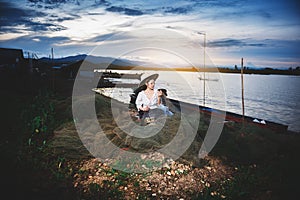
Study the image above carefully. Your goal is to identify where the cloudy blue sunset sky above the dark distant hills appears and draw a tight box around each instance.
[0,0,300,68]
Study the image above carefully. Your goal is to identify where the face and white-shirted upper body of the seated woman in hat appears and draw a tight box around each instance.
[135,79,162,119]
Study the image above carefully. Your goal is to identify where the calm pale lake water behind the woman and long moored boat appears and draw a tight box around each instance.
[96,70,300,132]
